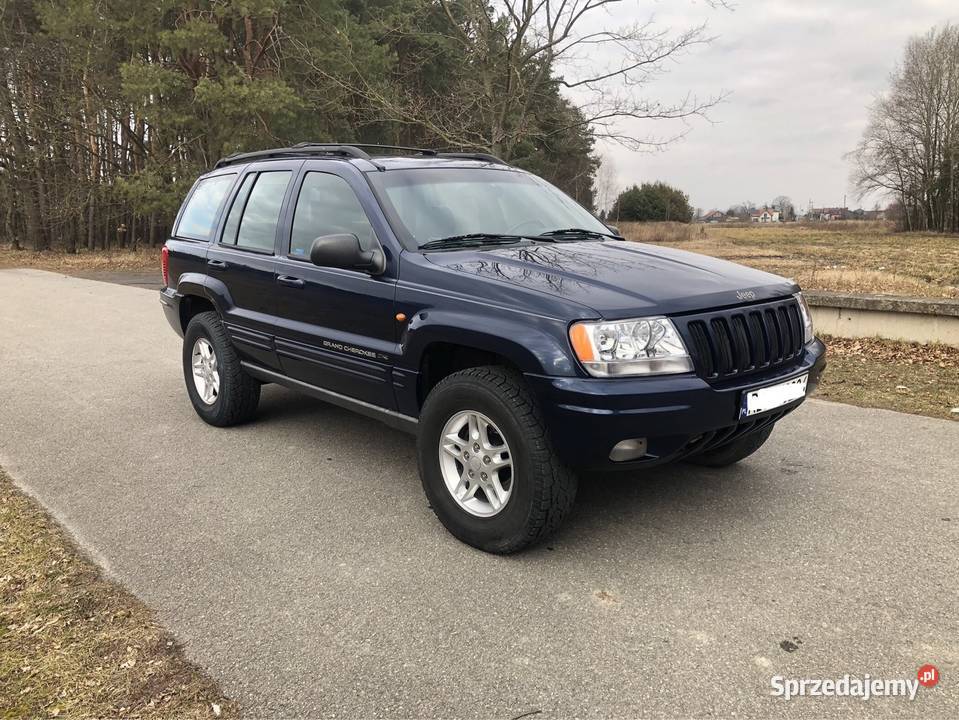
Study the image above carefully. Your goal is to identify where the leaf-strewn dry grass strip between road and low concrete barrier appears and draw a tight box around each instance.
[816,337,959,420]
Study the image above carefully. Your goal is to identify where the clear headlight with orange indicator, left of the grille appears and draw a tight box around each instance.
[569,317,693,377]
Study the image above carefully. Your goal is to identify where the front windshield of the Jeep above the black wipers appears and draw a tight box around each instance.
[367,168,610,247]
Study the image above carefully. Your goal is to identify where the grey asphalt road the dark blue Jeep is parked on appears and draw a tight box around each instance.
[0,270,959,719]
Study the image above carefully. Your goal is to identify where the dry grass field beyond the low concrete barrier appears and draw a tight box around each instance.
[619,221,959,298]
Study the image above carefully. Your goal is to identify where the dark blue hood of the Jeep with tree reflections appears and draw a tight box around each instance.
[425,240,798,319]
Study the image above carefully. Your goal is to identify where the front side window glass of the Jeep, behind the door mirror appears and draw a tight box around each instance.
[290,172,377,260]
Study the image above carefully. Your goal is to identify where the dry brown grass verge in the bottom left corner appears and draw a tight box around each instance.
[0,471,238,718]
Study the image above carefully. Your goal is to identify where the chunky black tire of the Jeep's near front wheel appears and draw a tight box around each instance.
[417,366,577,554]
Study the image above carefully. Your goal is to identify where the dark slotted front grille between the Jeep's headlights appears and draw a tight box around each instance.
[679,298,803,381]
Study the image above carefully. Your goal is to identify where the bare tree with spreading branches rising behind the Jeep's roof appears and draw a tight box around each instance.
[294,0,725,159]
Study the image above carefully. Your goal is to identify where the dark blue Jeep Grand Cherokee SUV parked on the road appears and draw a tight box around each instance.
[161,143,825,553]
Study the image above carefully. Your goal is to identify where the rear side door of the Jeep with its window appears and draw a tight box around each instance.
[207,161,302,369]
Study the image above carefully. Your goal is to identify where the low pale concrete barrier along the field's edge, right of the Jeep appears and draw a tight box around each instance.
[803,290,959,347]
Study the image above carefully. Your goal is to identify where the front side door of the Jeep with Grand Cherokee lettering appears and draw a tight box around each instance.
[275,161,397,409]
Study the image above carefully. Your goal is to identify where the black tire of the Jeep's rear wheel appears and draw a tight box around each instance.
[183,311,260,427]
